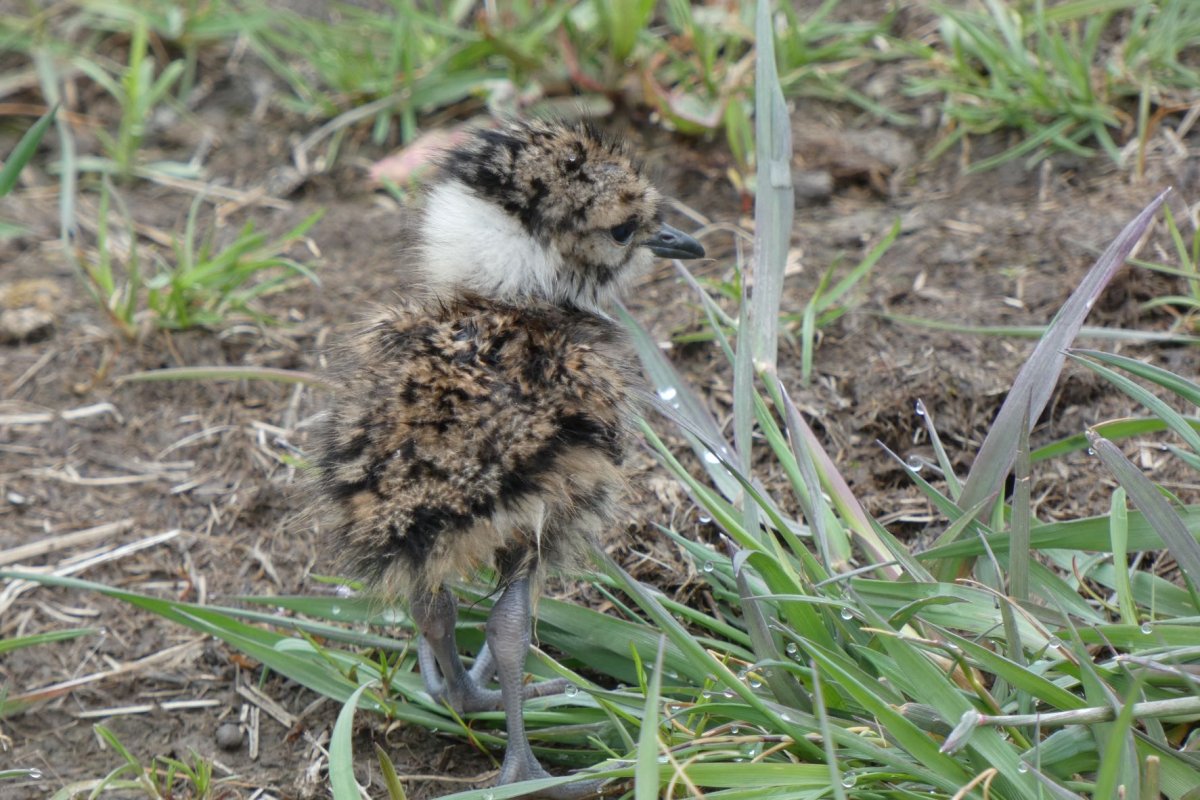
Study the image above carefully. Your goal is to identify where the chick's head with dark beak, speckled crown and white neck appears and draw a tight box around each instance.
[416,121,704,311]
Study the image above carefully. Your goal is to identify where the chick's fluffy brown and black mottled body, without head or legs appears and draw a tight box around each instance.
[319,296,635,597]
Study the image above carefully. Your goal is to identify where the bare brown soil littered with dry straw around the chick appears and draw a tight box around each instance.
[0,6,1200,799]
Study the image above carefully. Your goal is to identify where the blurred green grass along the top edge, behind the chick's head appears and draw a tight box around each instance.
[241,0,902,170]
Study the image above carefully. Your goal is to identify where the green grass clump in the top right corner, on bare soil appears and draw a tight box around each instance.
[910,0,1200,170]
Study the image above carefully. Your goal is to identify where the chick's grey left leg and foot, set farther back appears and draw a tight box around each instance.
[412,589,569,714]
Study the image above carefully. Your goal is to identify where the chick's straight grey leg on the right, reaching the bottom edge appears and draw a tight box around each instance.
[487,576,602,800]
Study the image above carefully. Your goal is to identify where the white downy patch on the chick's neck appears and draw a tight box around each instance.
[418,180,563,301]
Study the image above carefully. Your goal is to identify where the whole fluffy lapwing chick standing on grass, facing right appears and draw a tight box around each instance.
[318,122,704,800]
